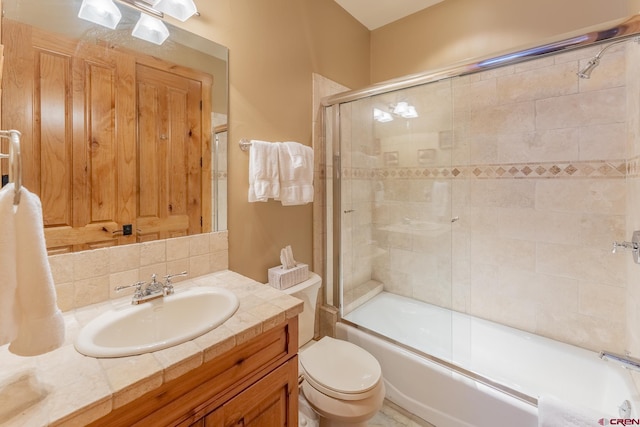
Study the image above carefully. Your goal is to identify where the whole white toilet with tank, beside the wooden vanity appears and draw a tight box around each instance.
[284,273,384,427]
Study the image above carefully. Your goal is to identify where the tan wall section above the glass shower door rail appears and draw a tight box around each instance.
[371,0,640,82]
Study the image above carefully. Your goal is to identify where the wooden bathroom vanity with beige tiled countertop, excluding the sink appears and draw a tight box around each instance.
[0,271,302,427]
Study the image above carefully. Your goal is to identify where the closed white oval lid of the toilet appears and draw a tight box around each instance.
[300,337,381,399]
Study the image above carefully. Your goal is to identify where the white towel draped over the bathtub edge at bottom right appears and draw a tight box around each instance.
[538,396,611,427]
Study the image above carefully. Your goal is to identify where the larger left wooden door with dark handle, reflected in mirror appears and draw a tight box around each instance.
[2,20,136,253]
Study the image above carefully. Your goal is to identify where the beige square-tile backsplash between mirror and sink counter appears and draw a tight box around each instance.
[49,231,229,311]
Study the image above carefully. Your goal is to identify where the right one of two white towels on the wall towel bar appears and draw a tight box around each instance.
[278,142,313,206]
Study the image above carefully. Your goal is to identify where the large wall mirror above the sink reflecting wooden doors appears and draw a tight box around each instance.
[2,0,228,254]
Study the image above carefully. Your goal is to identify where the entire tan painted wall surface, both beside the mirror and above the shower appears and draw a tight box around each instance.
[170,0,640,288]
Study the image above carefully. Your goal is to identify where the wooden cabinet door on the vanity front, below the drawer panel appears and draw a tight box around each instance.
[201,357,298,427]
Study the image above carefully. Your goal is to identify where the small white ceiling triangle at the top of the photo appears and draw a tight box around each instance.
[335,0,444,30]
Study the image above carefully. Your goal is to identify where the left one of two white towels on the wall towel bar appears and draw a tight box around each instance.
[249,140,281,202]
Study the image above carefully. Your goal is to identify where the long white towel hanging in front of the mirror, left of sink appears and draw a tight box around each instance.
[9,187,65,356]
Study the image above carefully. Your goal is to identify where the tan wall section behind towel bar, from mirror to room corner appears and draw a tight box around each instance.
[172,0,369,282]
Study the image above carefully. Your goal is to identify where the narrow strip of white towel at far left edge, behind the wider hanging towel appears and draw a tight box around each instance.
[0,184,18,345]
